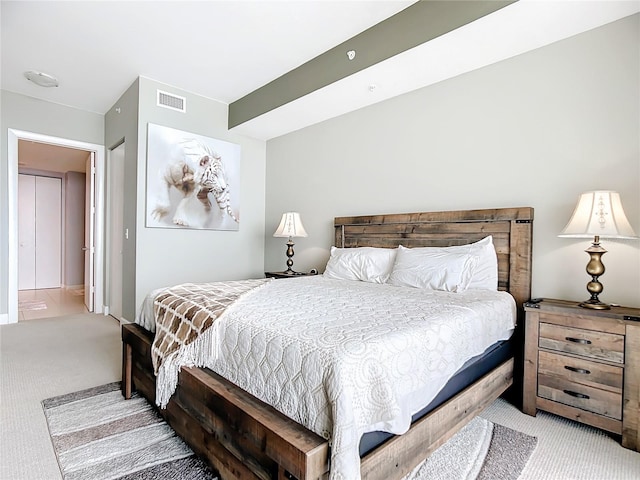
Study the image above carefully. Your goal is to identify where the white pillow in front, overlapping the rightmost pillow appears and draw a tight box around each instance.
[388,245,478,292]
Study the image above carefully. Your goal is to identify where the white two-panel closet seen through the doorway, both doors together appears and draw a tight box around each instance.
[18,174,62,290]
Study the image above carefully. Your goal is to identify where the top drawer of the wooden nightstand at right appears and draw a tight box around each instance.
[539,322,624,364]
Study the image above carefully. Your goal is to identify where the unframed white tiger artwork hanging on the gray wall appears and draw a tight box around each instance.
[146,123,240,230]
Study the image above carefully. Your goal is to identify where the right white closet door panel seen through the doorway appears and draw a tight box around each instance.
[35,177,62,288]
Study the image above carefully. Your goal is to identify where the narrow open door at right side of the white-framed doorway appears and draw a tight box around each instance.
[82,152,96,312]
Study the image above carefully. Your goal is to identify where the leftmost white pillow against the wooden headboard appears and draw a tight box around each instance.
[324,247,396,283]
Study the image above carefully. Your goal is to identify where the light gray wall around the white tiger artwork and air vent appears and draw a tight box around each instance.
[106,78,266,320]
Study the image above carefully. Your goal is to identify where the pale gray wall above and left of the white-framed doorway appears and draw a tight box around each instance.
[0,90,104,315]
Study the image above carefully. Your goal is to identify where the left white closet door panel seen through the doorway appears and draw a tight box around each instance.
[18,175,36,290]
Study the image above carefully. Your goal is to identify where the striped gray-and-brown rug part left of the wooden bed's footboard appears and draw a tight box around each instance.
[42,382,217,480]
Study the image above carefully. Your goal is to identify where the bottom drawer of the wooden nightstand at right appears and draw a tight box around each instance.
[538,374,622,420]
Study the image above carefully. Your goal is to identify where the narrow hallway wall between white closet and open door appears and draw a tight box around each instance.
[62,172,86,287]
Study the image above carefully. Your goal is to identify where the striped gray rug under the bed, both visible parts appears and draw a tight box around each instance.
[42,382,537,480]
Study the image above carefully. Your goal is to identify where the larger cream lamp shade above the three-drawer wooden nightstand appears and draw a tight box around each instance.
[558,191,638,239]
